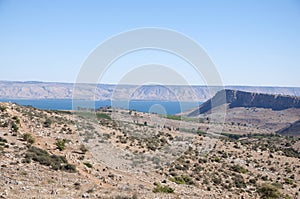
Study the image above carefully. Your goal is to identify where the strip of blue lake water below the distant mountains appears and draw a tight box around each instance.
[0,99,201,115]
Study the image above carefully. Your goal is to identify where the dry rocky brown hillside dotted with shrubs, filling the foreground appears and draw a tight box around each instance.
[0,90,300,199]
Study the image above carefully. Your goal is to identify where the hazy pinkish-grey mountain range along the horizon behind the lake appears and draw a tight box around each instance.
[0,81,300,102]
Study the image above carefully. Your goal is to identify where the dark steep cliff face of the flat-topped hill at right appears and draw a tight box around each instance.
[188,90,300,117]
